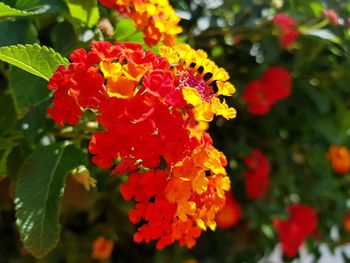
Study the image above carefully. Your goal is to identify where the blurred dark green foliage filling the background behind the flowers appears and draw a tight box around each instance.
[0,0,350,263]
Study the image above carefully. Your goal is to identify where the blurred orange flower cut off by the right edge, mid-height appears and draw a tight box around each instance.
[327,145,350,174]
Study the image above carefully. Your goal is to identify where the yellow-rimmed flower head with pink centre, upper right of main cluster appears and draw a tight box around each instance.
[160,44,236,122]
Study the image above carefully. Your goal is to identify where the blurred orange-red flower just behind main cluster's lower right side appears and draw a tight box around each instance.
[215,192,241,229]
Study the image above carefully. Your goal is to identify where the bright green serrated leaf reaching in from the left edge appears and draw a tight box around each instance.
[0,44,68,81]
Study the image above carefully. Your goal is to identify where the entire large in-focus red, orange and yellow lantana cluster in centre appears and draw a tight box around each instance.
[48,41,235,249]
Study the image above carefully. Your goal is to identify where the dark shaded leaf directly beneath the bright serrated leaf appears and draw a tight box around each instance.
[9,67,50,118]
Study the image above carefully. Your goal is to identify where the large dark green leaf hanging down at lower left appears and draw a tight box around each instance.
[15,143,86,257]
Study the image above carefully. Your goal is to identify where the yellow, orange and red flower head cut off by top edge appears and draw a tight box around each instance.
[100,0,182,46]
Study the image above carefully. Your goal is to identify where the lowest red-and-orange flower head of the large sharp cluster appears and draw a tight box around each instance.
[120,146,230,249]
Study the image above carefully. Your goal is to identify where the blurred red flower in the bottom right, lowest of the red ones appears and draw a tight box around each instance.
[273,204,318,257]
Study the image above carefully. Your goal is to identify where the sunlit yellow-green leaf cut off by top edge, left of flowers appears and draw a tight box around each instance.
[66,0,100,27]
